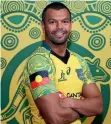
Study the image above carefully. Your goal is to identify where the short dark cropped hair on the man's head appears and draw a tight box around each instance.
[42,2,71,22]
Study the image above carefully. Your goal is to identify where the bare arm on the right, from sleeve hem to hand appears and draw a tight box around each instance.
[61,83,103,117]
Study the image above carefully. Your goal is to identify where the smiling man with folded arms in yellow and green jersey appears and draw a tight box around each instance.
[24,2,103,124]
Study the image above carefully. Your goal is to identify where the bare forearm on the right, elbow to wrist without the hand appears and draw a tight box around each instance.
[72,97,103,116]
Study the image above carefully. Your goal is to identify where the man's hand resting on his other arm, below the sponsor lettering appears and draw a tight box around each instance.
[60,98,73,108]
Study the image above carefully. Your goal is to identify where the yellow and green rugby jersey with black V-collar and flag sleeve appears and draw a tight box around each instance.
[24,43,94,124]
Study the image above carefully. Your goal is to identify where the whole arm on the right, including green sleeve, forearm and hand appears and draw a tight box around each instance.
[61,59,103,116]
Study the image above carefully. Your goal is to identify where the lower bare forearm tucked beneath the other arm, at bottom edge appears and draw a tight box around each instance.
[42,104,80,124]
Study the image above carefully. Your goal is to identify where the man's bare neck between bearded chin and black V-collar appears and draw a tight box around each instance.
[45,40,67,56]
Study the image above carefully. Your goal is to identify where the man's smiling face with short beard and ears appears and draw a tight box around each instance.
[42,9,71,45]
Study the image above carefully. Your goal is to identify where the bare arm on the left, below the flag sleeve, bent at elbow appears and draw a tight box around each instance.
[35,93,80,124]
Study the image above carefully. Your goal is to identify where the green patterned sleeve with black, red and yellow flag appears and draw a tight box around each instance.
[27,55,58,100]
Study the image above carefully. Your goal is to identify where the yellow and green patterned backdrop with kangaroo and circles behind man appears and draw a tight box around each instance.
[0,0,111,124]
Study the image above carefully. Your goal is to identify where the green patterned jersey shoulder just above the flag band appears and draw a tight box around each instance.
[26,46,55,75]
